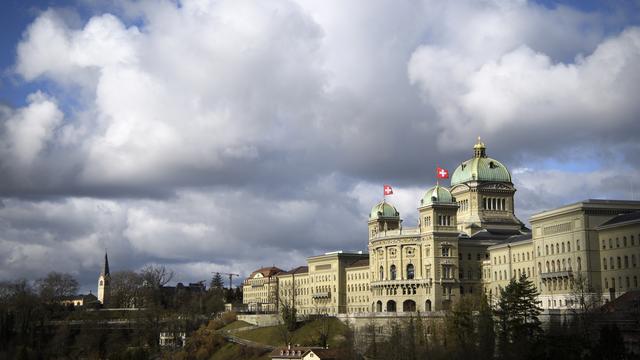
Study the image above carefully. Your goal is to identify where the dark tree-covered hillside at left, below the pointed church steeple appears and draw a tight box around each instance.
[0,266,241,359]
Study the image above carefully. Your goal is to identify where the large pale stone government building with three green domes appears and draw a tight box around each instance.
[243,140,640,314]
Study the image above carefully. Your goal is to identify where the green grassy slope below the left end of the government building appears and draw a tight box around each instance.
[236,318,347,348]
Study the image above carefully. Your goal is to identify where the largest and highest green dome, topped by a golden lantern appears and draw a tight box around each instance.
[451,139,511,186]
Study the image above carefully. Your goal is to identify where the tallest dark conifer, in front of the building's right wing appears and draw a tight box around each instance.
[495,275,542,359]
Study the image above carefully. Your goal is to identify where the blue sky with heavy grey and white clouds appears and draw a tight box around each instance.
[0,0,640,292]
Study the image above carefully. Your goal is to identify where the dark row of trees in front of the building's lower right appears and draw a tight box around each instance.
[360,276,634,360]
